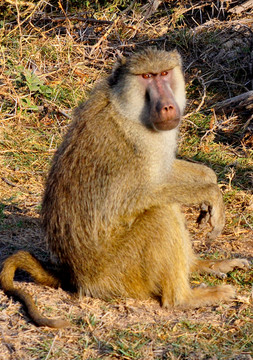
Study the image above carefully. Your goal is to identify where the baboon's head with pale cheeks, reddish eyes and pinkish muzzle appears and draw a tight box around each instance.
[111,51,186,131]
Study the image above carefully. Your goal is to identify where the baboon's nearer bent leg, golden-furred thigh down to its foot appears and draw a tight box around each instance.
[116,204,234,308]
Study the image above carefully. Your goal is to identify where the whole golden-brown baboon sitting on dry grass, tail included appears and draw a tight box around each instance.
[0,48,249,327]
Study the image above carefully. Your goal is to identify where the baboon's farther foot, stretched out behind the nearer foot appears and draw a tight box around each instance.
[191,259,250,278]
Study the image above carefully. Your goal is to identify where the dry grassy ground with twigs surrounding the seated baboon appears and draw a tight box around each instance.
[0,0,253,360]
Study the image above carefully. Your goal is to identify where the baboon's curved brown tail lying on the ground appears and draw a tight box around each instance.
[0,251,70,328]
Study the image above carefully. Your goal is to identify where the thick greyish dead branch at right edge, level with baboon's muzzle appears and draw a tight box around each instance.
[214,91,253,113]
